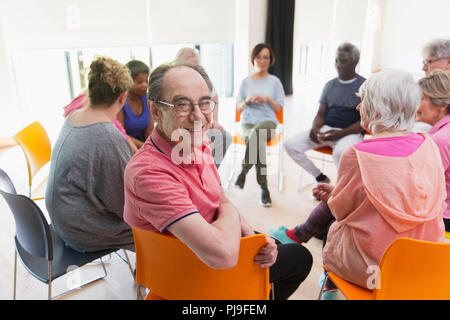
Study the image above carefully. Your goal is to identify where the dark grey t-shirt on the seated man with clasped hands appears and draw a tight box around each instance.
[319,75,366,129]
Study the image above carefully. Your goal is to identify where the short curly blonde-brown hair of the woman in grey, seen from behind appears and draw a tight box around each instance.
[88,56,133,106]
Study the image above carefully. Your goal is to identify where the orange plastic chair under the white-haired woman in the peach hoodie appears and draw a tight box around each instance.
[319,238,450,300]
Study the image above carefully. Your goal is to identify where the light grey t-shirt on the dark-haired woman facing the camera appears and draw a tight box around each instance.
[237,74,285,125]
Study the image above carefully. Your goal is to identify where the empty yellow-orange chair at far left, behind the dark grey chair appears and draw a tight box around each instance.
[13,121,52,200]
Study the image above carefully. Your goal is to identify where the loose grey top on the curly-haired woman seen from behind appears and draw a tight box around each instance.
[45,118,133,251]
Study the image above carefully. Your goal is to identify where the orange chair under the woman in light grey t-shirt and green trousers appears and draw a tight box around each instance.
[227,106,284,192]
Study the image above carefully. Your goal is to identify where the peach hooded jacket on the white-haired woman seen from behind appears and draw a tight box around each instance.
[323,134,446,287]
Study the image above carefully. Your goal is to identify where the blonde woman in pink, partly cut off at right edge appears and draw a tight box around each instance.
[417,70,450,231]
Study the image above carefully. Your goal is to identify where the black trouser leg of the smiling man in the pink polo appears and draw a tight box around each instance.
[269,240,313,300]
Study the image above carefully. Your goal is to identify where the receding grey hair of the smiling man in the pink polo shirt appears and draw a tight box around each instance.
[148,61,213,101]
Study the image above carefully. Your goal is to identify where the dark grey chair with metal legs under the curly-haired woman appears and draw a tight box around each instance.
[0,169,129,300]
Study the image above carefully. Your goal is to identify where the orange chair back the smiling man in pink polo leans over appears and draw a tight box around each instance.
[132,228,270,300]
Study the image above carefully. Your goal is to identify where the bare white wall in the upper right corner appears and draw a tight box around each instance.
[376,0,450,78]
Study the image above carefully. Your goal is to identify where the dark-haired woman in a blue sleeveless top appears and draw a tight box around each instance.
[117,60,153,148]
